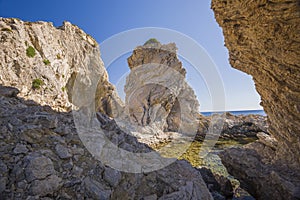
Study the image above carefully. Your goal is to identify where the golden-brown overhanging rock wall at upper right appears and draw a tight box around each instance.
[212,0,300,167]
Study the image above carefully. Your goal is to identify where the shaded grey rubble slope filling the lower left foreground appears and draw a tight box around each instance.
[0,86,212,200]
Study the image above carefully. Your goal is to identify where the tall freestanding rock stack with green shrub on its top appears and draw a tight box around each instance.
[121,42,199,144]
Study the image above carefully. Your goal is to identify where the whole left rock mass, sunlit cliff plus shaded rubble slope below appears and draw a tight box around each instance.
[0,18,212,200]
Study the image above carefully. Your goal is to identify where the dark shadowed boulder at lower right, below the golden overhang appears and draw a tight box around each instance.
[220,143,300,200]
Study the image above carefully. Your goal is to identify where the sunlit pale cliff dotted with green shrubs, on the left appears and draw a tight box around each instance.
[0,18,122,115]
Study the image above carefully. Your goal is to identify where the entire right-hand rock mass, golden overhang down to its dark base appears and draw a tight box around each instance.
[212,0,300,199]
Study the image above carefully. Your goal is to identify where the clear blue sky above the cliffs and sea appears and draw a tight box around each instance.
[0,0,262,111]
